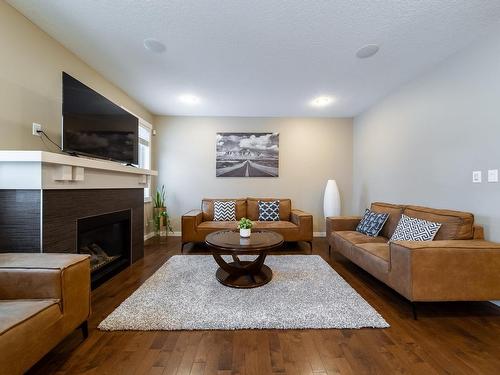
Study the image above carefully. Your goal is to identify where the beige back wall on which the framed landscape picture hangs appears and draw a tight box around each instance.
[153,117,352,232]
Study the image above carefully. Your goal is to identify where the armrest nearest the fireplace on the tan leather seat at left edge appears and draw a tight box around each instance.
[0,253,90,324]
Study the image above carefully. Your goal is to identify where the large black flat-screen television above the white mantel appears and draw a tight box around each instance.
[62,72,139,165]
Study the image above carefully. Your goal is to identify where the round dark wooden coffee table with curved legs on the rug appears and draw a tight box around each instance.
[205,230,283,288]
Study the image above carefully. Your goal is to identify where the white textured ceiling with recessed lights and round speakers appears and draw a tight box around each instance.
[8,0,500,117]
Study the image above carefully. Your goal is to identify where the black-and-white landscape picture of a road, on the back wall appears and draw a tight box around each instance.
[215,133,279,177]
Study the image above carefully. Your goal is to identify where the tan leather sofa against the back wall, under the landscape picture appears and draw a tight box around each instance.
[181,198,313,249]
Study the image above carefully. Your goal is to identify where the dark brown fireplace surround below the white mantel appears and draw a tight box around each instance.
[0,188,144,286]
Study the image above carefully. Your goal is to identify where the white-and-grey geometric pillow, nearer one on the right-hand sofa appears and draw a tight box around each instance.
[389,215,441,242]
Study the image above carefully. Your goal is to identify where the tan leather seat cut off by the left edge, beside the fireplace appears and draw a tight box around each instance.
[0,253,90,374]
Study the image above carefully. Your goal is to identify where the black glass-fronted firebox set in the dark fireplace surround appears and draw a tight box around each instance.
[77,210,132,288]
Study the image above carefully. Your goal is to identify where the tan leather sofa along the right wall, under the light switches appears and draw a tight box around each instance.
[326,202,500,312]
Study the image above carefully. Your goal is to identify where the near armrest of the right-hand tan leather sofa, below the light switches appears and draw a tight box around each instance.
[390,240,500,301]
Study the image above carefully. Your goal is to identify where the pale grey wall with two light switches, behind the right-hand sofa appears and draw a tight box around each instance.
[353,33,500,241]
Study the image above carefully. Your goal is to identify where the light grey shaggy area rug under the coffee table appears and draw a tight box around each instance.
[99,255,389,331]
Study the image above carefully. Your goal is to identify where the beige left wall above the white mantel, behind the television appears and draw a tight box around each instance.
[0,1,153,151]
